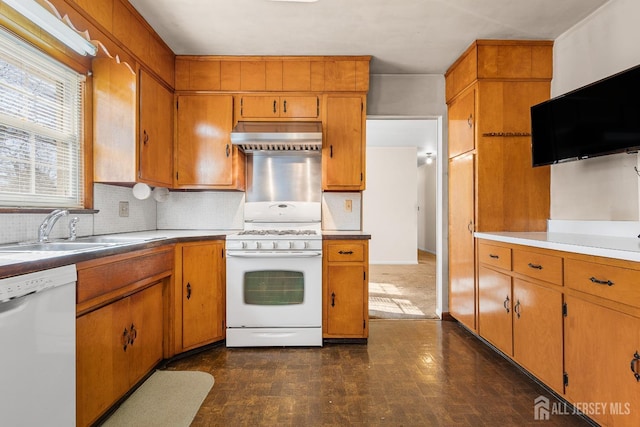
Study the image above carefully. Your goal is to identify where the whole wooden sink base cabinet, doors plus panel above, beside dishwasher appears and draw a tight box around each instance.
[76,247,173,426]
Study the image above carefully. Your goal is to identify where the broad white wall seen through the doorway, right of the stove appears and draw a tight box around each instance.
[362,147,418,264]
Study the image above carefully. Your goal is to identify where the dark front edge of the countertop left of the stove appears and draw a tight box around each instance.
[0,234,227,279]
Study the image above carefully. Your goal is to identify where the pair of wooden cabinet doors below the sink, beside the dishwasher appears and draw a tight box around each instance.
[76,282,163,426]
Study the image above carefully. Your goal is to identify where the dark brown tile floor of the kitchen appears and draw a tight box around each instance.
[167,320,589,427]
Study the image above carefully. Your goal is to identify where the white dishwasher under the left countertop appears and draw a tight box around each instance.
[0,265,77,427]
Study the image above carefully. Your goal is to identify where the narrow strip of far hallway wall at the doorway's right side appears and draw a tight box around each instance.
[418,162,437,254]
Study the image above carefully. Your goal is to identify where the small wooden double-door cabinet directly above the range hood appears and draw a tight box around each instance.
[238,95,320,119]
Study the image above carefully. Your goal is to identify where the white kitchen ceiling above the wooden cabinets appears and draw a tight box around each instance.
[129,0,608,74]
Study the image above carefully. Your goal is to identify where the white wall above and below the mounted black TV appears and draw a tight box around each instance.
[551,0,640,221]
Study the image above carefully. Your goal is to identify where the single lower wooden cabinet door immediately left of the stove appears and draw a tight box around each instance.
[172,242,225,354]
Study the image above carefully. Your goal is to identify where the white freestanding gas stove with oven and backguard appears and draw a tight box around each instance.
[226,202,322,347]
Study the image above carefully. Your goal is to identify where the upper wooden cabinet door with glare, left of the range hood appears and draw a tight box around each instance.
[176,95,233,187]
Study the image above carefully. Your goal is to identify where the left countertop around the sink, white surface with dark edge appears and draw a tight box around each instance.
[0,230,232,279]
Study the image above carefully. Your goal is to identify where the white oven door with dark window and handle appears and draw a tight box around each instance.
[226,251,322,328]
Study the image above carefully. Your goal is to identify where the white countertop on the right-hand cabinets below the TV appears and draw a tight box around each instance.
[474,232,640,262]
